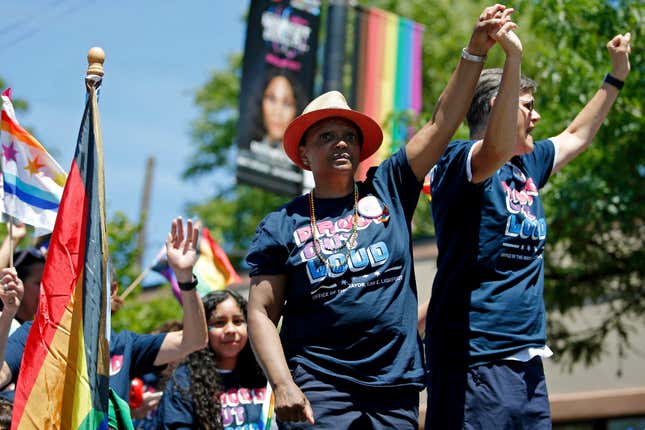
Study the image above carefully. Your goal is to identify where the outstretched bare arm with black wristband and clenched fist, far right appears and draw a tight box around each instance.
[552,33,631,174]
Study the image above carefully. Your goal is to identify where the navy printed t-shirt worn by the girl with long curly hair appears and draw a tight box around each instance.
[157,364,266,430]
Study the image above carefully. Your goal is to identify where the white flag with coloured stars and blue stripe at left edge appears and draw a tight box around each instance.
[0,88,67,234]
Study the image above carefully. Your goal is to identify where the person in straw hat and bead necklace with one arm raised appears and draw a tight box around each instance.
[246,5,516,429]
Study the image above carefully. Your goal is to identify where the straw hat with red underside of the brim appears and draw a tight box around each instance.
[282,91,383,170]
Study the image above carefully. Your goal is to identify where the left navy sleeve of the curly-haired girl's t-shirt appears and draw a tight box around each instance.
[157,366,194,430]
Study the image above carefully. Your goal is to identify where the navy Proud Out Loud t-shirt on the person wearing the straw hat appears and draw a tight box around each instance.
[246,148,423,388]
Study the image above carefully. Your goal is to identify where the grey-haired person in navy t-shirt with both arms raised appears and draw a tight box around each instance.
[426,29,631,429]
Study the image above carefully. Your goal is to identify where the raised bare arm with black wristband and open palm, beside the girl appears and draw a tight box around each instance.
[154,217,208,366]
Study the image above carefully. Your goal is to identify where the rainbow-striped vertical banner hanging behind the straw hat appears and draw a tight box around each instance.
[352,7,424,177]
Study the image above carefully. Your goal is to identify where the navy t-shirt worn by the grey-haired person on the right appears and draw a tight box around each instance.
[426,140,555,365]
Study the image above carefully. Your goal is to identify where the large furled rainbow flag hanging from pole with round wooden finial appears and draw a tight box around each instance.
[11,80,109,430]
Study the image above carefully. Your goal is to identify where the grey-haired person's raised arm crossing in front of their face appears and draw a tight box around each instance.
[470,22,522,183]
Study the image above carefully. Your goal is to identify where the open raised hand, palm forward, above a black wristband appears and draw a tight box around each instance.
[166,217,199,282]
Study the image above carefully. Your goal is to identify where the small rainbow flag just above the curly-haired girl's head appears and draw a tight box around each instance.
[194,227,242,297]
